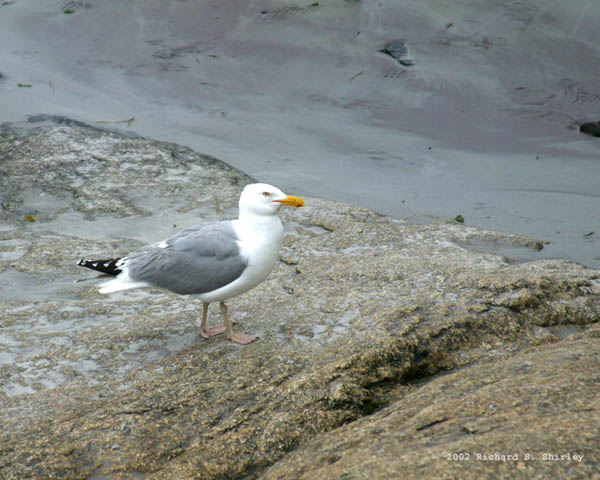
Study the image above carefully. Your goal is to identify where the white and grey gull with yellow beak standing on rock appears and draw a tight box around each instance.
[78,183,304,344]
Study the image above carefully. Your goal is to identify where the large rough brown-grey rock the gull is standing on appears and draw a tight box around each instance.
[0,121,600,480]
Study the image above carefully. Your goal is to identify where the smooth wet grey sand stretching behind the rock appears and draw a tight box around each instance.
[0,0,600,268]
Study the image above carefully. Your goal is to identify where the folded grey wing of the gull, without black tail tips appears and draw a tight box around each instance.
[123,222,248,295]
